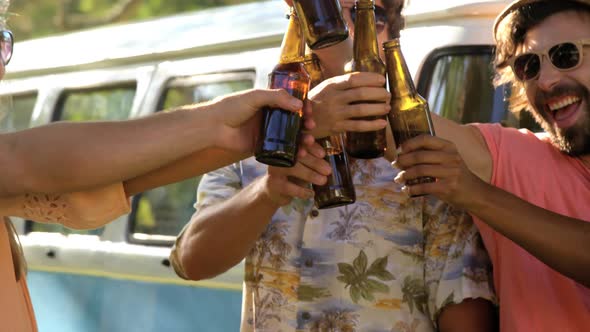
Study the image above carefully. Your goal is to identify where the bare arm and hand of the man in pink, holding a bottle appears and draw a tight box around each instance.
[396,136,590,287]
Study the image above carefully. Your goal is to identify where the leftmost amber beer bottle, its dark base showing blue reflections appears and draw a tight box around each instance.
[255,12,310,167]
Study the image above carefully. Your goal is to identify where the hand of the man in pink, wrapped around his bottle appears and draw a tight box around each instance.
[393,135,486,208]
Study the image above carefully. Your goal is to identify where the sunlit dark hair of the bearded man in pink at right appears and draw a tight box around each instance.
[494,1,590,112]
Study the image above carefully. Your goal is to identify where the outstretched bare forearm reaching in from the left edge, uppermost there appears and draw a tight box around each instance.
[0,106,216,196]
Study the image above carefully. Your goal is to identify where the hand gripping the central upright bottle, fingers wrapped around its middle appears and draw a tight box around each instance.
[305,72,391,138]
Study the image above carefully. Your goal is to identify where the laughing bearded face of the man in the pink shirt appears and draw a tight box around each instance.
[518,11,590,156]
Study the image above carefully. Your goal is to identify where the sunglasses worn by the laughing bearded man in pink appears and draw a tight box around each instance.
[508,39,590,82]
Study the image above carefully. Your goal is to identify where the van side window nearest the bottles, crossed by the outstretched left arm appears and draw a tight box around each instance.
[129,73,254,245]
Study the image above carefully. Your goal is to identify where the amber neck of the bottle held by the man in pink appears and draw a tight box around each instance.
[385,43,417,98]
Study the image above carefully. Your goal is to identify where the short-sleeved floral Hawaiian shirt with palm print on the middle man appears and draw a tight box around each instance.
[175,158,495,332]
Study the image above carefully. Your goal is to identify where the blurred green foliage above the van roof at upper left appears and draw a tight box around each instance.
[8,0,262,40]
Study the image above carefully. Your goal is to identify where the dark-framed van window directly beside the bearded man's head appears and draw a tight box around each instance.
[418,45,539,131]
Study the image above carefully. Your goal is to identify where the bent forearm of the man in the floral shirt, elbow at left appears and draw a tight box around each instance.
[177,177,279,280]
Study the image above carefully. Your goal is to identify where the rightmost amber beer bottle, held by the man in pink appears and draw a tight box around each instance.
[383,38,435,186]
